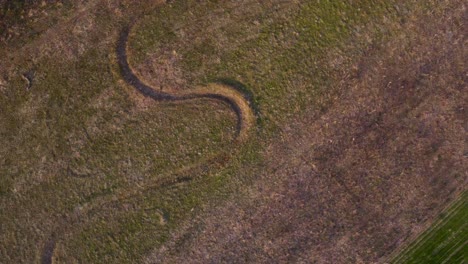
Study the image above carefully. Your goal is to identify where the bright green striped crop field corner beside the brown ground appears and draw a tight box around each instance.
[391,192,468,263]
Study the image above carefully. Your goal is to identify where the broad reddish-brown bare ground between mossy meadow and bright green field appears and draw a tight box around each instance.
[147,1,468,263]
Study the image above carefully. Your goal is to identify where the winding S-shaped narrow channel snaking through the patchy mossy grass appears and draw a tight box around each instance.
[41,23,255,264]
